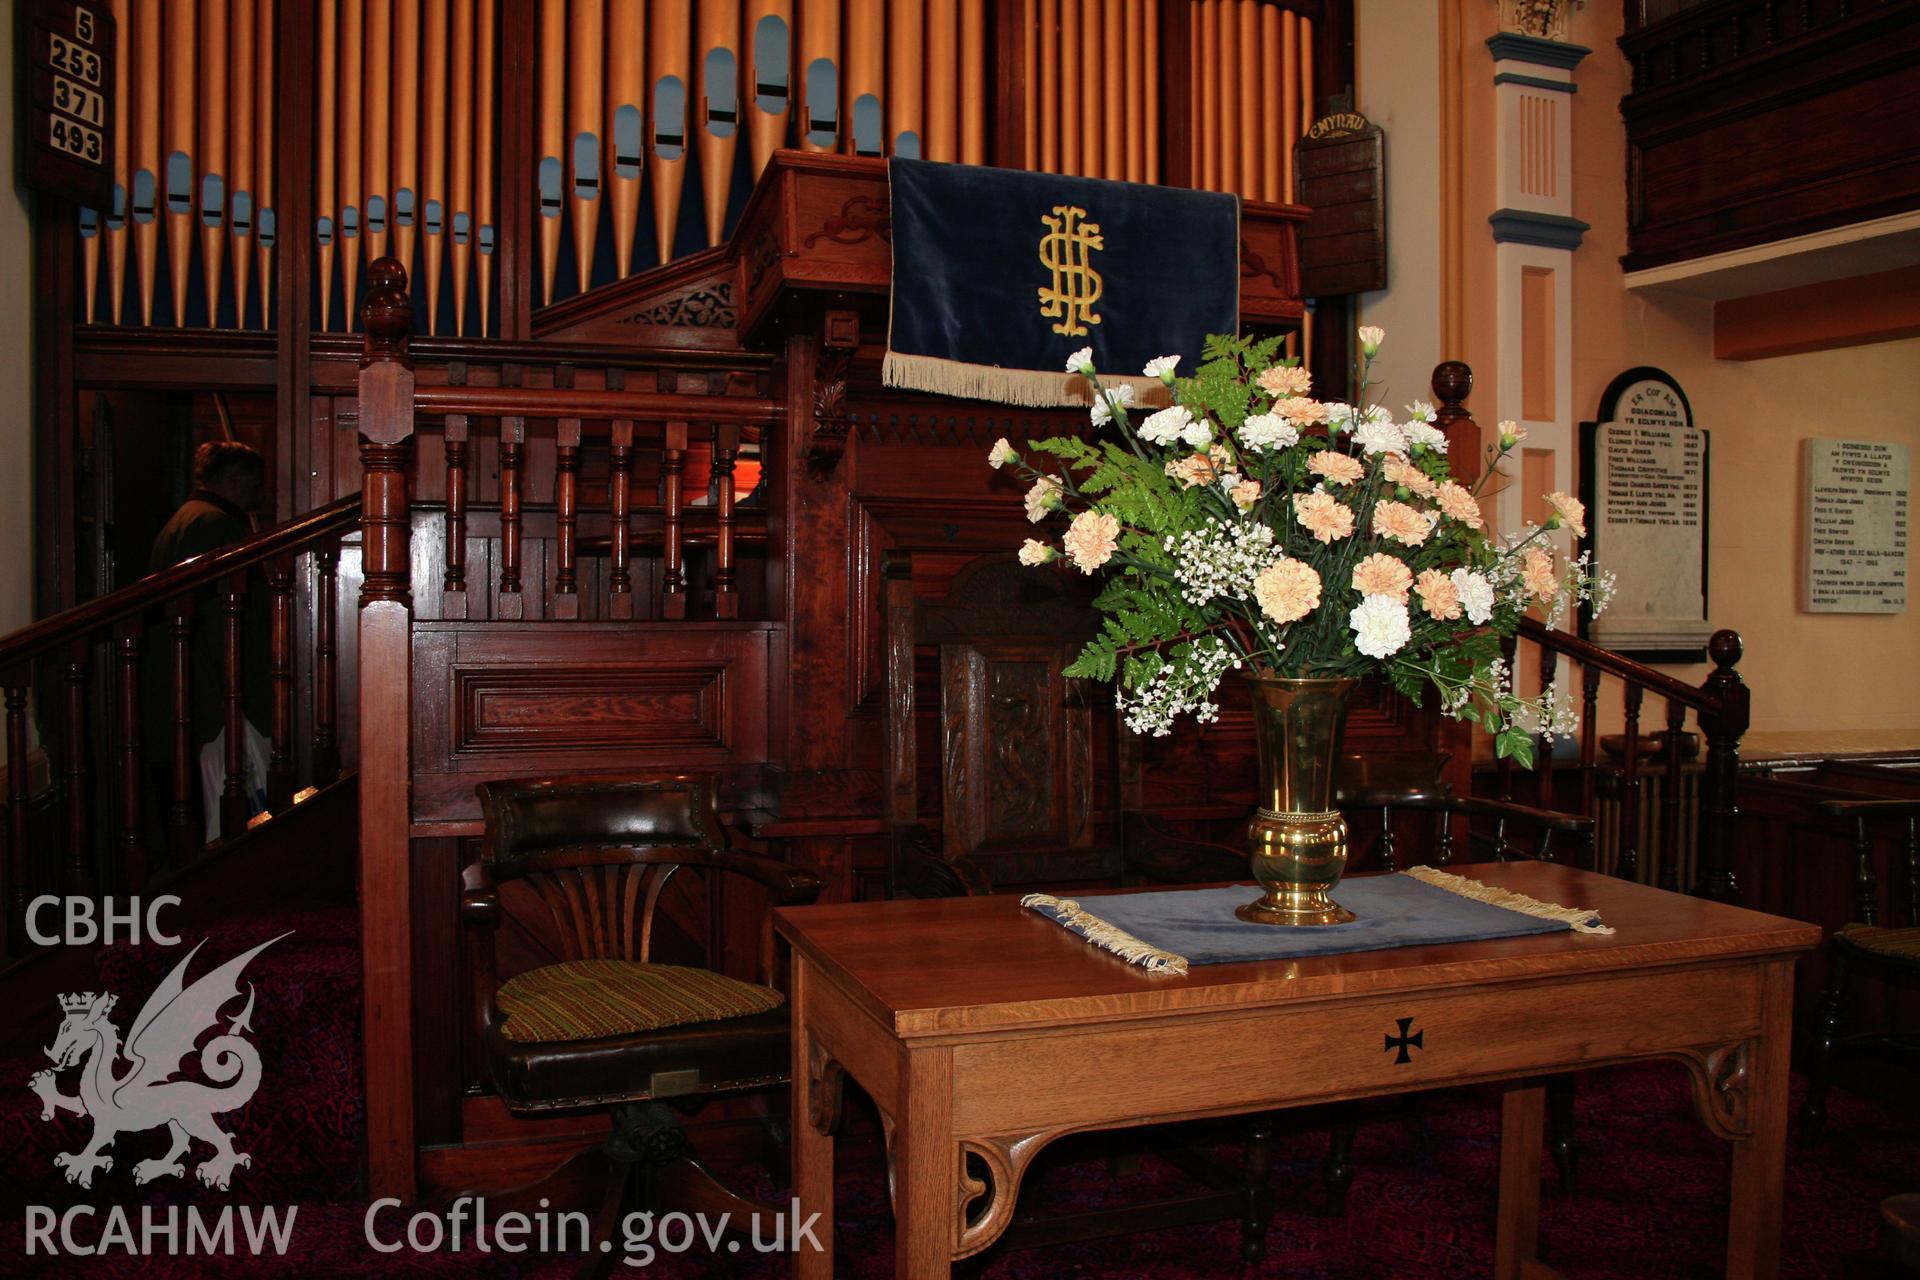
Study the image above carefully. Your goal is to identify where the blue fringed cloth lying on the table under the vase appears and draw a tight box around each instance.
[1021,867,1613,973]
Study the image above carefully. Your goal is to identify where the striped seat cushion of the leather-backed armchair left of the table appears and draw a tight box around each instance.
[497,960,785,1044]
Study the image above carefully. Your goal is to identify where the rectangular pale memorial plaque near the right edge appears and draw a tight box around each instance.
[1801,439,1908,614]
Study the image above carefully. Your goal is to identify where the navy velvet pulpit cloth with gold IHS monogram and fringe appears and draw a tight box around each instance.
[881,157,1240,405]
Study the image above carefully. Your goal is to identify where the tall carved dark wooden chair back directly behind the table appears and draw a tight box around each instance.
[883,553,1121,896]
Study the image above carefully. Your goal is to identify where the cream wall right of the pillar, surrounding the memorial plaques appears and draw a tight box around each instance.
[1559,4,1920,754]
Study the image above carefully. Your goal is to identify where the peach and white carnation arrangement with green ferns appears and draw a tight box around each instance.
[987,326,1611,764]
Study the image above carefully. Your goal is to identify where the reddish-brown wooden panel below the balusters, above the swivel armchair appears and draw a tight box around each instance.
[413,622,776,823]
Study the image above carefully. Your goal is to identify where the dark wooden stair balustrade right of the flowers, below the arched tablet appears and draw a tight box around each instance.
[1432,361,1749,902]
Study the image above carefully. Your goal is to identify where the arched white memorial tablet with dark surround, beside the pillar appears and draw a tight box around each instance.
[1580,368,1713,662]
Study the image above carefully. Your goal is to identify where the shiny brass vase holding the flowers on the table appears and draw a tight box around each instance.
[1235,676,1359,925]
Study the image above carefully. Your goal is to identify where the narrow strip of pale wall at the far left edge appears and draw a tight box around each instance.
[0,21,33,635]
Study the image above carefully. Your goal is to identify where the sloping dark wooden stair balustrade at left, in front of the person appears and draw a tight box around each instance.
[0,497,359,954]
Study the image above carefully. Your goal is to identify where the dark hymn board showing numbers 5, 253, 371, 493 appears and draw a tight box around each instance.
[21,0,119,209]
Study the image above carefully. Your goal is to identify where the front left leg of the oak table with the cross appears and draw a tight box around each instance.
[893,1048,960,1280]
